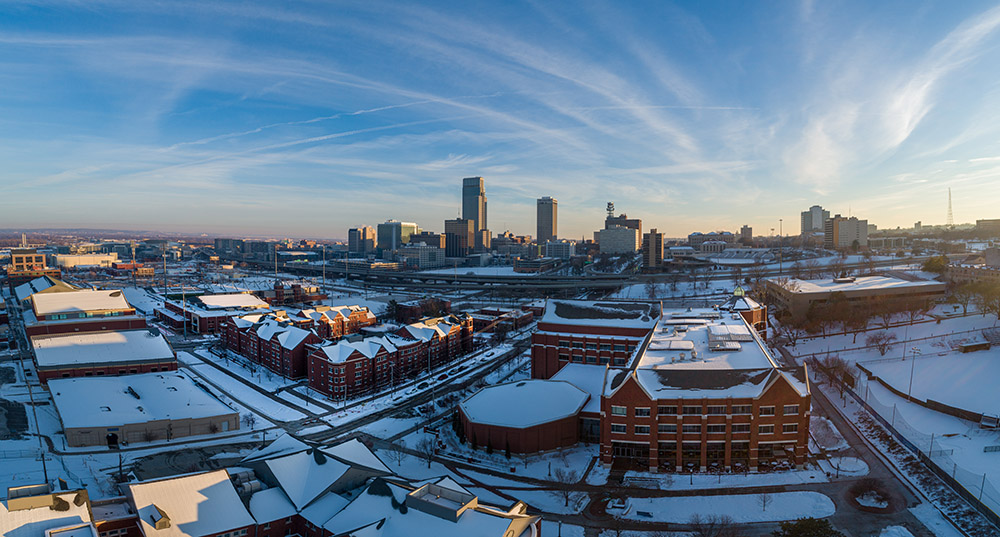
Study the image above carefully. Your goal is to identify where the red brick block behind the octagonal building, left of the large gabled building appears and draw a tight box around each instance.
[531,300,660,379]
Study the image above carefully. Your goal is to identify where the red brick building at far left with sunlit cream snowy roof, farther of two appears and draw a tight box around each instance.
[24,289,146,338]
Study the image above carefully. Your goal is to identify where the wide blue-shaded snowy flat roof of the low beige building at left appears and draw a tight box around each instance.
[49,371,235,428]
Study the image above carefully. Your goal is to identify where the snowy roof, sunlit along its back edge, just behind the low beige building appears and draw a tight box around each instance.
[31,329,174,368]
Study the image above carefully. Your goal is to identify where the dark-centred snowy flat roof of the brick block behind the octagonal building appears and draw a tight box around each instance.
[539,300,660,329]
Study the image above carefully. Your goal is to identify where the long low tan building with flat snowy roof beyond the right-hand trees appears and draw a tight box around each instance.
[765,276,946,320]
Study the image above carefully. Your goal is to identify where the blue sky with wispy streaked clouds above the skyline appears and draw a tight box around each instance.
[0,0,1000,238]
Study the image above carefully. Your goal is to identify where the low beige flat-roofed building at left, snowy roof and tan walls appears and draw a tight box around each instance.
[49,371,240,447]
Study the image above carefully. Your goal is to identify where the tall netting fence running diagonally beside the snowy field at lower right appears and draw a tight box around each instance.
[845,375,1000,526]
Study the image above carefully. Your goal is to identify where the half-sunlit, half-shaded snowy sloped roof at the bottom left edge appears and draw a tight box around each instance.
[129,470,255,537]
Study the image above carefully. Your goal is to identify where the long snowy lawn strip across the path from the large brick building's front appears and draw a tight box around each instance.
[620,491,836,524]
